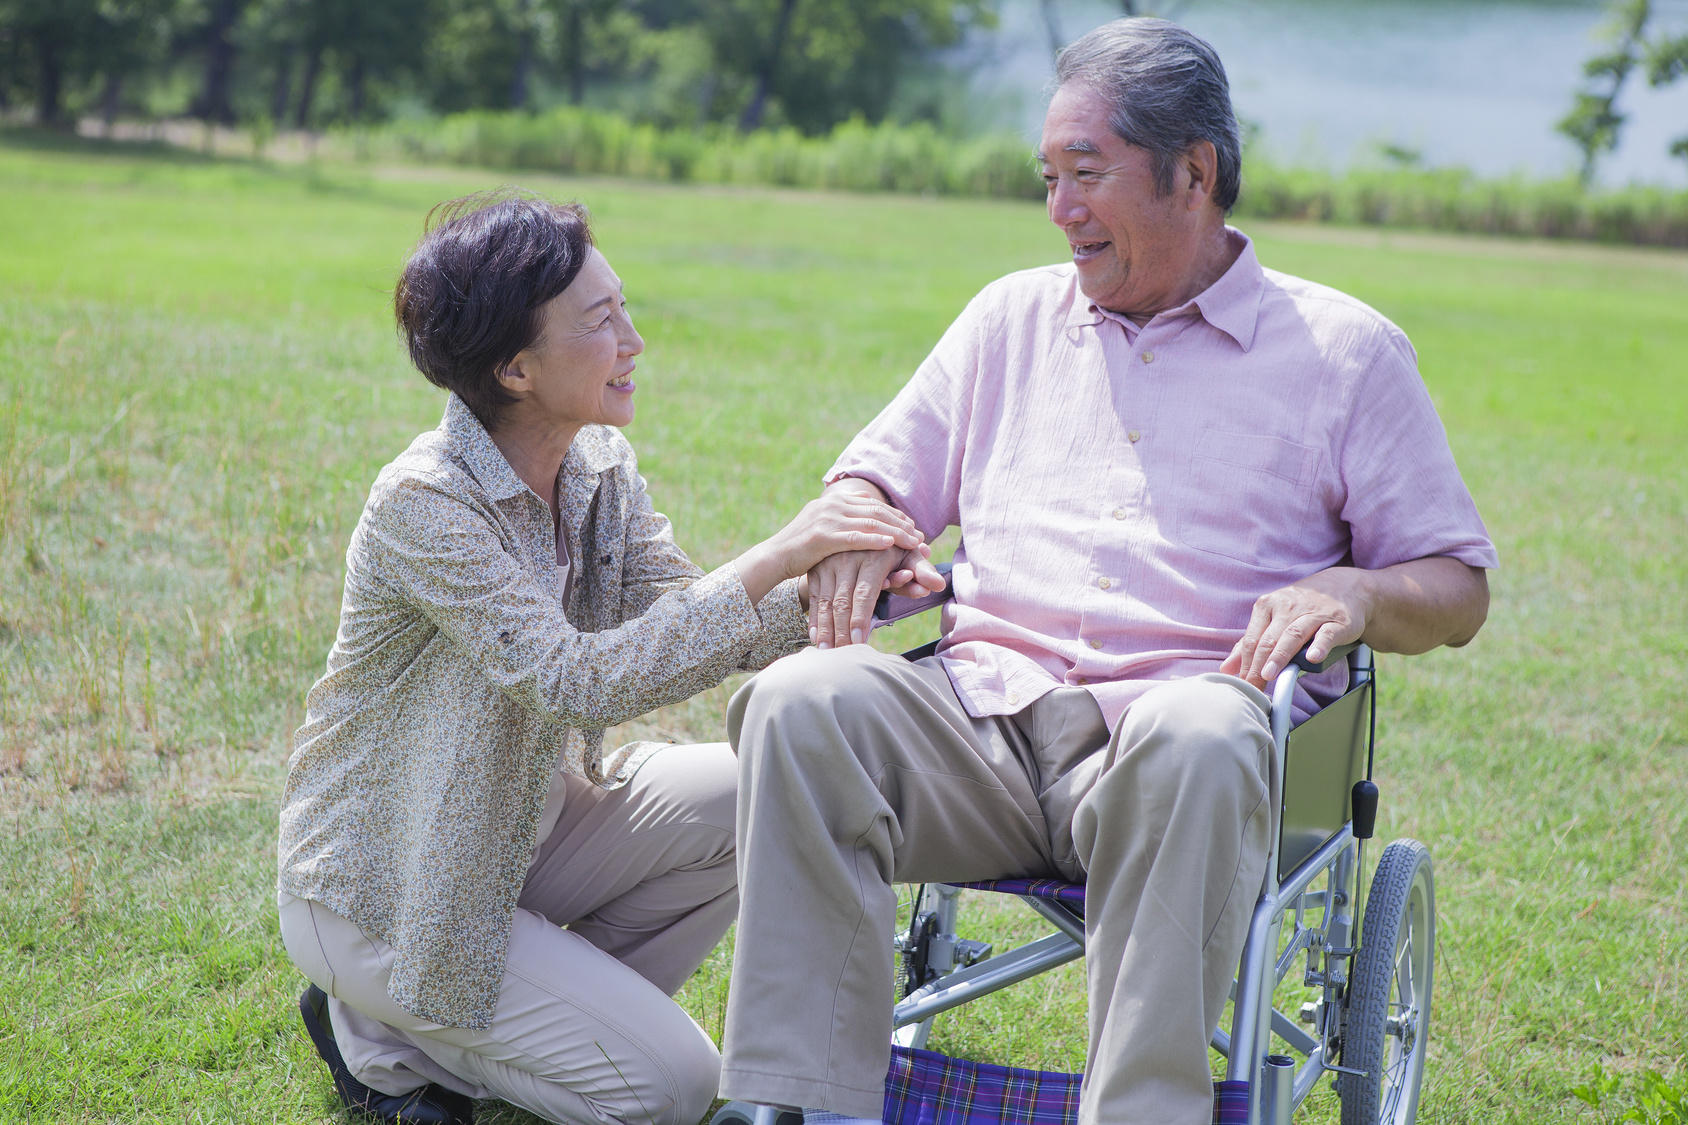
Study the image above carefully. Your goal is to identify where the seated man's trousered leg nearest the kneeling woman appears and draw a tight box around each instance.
[721,645,1052,1118]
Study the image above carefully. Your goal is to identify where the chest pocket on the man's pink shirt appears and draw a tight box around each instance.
[1178,429,1328,568]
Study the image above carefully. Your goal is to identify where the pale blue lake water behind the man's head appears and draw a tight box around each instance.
[955,0,1688,188]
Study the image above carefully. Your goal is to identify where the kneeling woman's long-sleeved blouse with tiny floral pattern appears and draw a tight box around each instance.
[279,395,809,1027]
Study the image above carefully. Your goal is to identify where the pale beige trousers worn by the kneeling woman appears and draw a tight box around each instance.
[279,743,738,1125]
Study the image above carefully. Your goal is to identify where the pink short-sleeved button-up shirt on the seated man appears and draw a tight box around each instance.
[827,231,1496,725]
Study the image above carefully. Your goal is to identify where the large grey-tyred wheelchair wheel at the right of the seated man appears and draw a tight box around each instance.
[1337,840,1436,1125]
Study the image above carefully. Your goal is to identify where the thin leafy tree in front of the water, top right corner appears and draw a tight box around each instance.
[1556,0,1688,186]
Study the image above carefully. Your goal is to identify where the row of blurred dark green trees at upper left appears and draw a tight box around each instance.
[0,0,994,133]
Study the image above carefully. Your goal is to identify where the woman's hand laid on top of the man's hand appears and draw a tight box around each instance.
[734,488,925,601]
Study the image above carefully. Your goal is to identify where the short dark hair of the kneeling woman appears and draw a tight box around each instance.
[393,191,592,429]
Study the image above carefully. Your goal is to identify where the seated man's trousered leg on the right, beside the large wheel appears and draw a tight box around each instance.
[1074,674,1274,1125]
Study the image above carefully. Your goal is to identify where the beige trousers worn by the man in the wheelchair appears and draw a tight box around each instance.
[721,645,1274,1125]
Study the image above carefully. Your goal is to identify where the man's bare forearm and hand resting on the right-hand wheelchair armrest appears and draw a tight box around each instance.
[1219,556,1489,688]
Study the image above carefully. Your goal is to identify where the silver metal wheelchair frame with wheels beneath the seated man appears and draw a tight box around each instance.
[711,603,1435,1125]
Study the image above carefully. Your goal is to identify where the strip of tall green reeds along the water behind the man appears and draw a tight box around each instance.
[317,106,1688,247]
